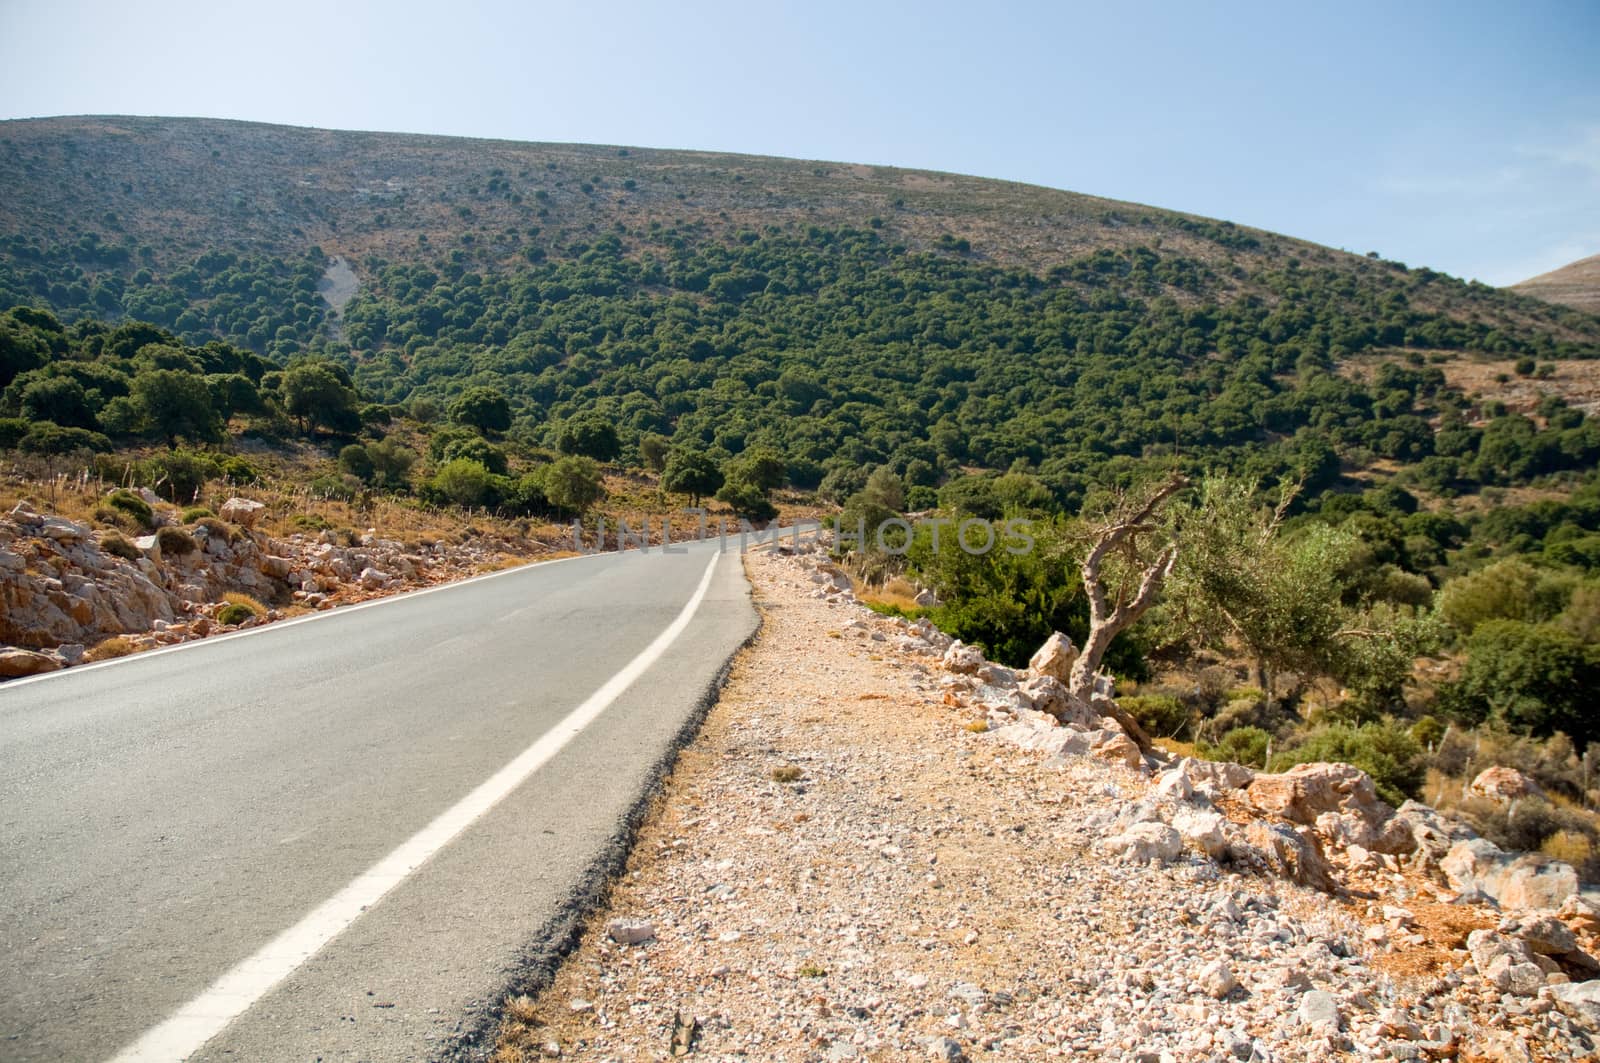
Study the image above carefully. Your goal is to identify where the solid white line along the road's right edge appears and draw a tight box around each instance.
[110,554,718,1063]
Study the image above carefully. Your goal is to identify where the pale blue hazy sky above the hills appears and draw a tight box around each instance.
[0,0,1600,283]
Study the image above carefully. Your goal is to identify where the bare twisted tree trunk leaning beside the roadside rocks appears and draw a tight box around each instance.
[1067,475,1189,703]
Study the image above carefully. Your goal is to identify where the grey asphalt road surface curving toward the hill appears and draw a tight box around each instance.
[0,543,757,1061]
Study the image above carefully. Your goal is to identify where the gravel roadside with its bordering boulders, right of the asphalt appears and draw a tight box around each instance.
[496,552,1600,1063]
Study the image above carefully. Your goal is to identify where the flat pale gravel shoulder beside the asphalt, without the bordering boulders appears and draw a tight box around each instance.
[494,552,1595,1063]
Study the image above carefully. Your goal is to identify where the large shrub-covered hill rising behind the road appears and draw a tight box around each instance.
[0,117,1600,504]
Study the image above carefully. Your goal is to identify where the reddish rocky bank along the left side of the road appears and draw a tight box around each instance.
[0,496,534,679]
